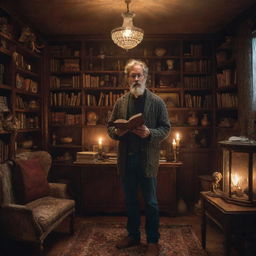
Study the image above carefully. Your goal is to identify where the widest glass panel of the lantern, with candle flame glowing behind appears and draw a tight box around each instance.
[231,152,249,200]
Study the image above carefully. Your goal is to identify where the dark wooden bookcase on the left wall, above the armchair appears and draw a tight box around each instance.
[0,9,43,161]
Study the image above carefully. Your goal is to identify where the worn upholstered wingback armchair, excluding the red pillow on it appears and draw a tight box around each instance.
[0,151,75,252]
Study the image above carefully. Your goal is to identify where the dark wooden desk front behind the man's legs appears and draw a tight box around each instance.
[51,161,181,216]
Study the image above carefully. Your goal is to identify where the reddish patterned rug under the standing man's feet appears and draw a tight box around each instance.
[59,223,207,256]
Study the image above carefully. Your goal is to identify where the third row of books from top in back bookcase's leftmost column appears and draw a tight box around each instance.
[50,75,80,89]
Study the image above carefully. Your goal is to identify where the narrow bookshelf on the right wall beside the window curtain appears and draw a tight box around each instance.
[215,35,240,141]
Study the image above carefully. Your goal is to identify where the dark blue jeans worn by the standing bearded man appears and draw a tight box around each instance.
[122,154,160,243]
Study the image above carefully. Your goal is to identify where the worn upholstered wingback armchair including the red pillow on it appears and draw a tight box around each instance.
[0,151,75,252]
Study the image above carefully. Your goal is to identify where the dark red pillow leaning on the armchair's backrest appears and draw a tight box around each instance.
[13,158,49,203]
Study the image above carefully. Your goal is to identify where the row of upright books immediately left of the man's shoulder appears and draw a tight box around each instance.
[85,92,125,107]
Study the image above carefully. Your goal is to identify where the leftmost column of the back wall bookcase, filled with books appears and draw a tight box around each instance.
[48,42,84,162]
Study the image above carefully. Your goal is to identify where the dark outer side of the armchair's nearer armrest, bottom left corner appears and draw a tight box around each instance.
[0,204,43,241]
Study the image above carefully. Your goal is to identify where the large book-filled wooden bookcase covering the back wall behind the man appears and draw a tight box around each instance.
[48,36,215,204]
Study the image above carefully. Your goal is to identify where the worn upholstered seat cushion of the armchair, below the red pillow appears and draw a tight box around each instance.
[26,196,75,231]
